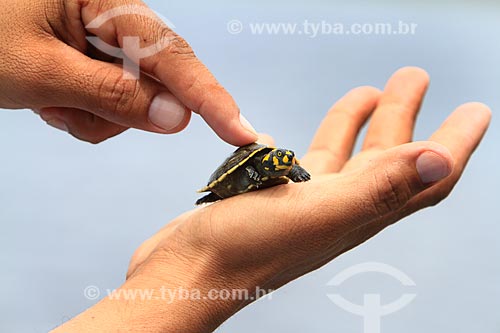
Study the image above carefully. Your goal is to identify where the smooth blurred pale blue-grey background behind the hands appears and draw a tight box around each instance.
[0,0,500,333]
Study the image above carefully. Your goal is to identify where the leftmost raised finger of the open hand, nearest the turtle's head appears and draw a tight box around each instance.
[302,87,380,174]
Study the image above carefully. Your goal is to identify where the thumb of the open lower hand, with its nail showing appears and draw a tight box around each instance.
[351,142,454,222]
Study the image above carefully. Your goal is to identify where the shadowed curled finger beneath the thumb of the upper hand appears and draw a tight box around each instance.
[37,108,128,144]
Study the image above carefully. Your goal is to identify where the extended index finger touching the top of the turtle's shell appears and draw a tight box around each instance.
[82,0,257,146]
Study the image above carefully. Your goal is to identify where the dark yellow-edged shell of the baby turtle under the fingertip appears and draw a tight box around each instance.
[198,143,274,193]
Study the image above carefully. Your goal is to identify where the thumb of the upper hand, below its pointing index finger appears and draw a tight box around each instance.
[26,41,191,133]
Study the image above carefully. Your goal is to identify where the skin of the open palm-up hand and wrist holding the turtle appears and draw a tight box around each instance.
[54,68,491,333]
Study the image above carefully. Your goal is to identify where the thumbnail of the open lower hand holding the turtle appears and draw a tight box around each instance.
[417,151,451,184]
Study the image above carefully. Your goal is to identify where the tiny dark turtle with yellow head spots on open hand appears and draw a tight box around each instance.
[196,143,311,205]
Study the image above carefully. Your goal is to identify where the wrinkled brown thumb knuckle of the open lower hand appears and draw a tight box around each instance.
[370,170,412,217]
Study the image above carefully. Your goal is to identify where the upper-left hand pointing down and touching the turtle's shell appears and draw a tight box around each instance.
[0,0,257,145]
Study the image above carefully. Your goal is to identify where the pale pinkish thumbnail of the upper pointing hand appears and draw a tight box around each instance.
[149,92,187,131]
